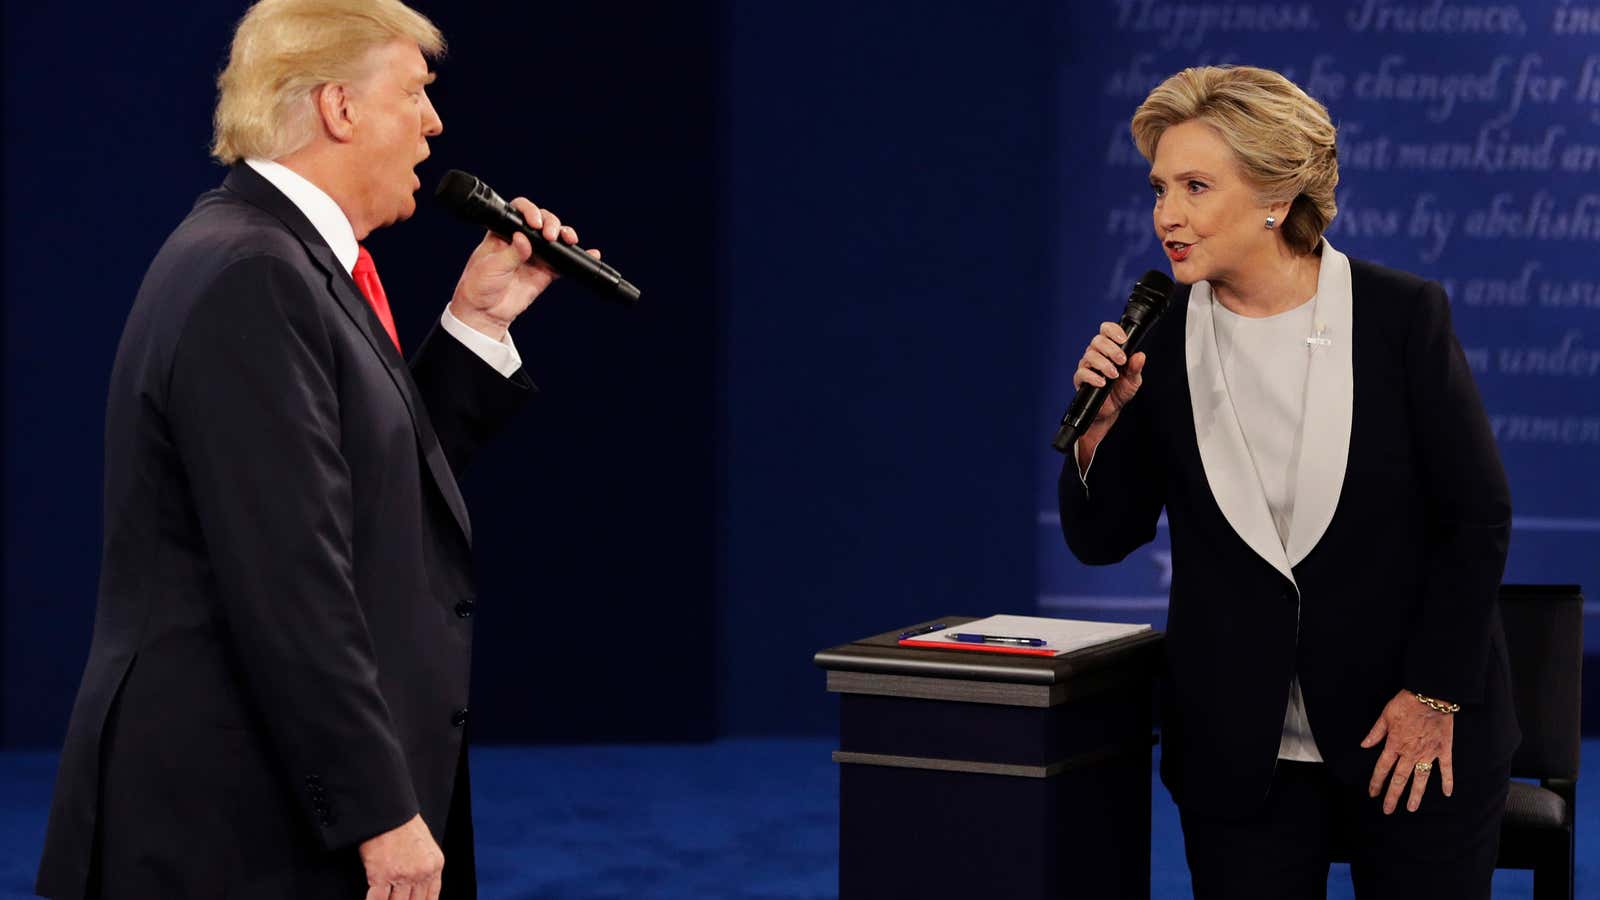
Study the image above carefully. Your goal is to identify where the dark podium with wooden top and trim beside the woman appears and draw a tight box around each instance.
[814,617,1162,900]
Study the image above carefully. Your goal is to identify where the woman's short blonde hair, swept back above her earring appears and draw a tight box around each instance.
[1131,66,1339,253]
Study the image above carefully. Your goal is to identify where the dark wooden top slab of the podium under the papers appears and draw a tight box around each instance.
[811,615,1163,685]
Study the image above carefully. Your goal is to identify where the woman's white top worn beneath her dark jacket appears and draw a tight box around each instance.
[1211,298,1322,762]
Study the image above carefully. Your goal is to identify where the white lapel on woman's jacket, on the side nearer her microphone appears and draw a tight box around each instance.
[1184,282,1294,581]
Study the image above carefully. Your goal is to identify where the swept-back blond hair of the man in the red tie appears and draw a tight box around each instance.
[211,0,445,165]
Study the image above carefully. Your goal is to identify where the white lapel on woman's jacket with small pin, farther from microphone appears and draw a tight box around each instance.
[1286,240,1355,565]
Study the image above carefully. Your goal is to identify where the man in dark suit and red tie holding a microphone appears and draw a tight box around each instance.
[37,0,598,900]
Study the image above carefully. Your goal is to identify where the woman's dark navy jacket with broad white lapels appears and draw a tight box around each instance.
[1059,245,1520,817]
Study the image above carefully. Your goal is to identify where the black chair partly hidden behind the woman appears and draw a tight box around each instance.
[1498,585,1584,900]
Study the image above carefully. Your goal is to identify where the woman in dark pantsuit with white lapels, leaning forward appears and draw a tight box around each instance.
[1059,67,1520,900]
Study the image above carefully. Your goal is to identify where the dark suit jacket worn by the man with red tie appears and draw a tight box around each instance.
[37,165,531,898]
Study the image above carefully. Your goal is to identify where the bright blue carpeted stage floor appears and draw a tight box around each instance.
[0,740,1600,900]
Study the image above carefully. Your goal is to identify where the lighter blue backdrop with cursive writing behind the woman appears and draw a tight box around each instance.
[1037,0,1600,653]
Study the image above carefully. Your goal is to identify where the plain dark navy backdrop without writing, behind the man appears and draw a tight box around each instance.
[0,0,1054,748]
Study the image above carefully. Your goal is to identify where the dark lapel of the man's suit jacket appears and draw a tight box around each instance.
[224,163,472,544]
